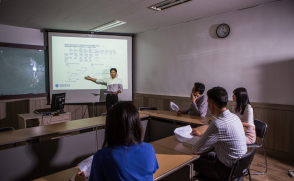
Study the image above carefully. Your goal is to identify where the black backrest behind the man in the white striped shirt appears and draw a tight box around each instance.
[229,148,256,180]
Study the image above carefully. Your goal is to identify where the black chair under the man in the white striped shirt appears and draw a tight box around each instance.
[194,148,256,181]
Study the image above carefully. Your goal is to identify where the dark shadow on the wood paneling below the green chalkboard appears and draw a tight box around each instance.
[0,100,30,129]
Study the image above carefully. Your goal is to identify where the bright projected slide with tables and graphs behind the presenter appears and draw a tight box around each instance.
[52,36,129,90]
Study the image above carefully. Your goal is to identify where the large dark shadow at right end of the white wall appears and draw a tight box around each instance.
[259,58,294,105]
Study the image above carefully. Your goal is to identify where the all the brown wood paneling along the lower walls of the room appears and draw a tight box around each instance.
[0,93,294,162]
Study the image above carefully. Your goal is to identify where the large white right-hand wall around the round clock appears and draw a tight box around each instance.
[134,0,294,105]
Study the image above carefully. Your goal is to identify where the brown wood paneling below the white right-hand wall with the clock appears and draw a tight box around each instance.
[134,93,294,163]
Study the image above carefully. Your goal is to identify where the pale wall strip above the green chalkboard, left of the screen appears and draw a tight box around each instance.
[0,24,44,46]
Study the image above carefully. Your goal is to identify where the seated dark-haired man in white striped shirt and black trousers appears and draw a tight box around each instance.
[192,87,247,180]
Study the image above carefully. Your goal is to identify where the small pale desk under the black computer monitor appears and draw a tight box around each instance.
[18,112,71,129]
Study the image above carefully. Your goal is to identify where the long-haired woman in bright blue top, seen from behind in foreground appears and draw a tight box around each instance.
[75,102,158,181]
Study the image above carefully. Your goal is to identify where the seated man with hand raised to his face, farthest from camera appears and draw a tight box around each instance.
[178,82,207,116]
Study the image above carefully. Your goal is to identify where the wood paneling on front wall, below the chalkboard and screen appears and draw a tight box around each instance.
[0,97,89,129]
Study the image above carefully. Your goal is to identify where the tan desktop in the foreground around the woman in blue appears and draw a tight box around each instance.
[34,143,198,181]
